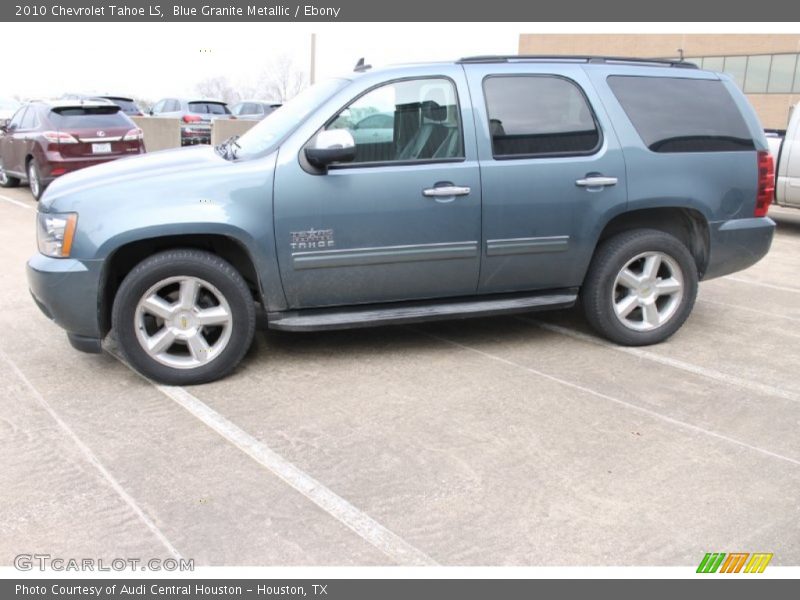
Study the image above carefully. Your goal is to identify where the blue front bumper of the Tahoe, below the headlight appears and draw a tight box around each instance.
[27,254,103,350]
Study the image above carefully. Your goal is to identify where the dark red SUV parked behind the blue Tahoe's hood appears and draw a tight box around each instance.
[0,100,144,200]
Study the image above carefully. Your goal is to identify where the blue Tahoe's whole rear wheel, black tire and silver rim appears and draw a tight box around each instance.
[581,229,697,346]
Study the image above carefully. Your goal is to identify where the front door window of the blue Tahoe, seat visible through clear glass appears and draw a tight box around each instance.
[325,78,464,164]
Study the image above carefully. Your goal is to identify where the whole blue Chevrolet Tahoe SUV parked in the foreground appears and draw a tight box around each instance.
[28,57,775,384]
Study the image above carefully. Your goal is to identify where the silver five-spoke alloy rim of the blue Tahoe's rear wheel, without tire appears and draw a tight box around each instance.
[611,252,684,331]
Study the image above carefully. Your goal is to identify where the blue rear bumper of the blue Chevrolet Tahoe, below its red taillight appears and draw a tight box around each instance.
[703,217,775,280]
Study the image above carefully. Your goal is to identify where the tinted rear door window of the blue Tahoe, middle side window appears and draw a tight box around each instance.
[483,75,600,158]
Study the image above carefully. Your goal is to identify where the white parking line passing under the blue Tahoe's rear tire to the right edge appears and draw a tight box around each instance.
[517,317,800,402]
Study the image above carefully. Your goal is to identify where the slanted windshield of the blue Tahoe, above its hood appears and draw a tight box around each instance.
[236,79,349,158]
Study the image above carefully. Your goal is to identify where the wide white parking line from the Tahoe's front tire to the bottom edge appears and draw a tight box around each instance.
[111,352,438,566]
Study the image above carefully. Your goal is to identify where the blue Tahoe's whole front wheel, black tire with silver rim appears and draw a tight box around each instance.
[112,250,255,385]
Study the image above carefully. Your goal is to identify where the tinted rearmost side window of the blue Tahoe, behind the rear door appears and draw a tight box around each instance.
[608,75,755,152]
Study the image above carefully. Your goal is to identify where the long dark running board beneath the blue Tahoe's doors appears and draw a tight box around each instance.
[267,289,578,331]
